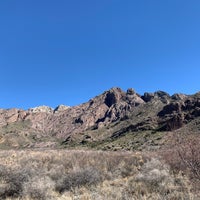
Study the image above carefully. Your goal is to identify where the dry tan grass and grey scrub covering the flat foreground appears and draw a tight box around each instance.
[0,150,198,200]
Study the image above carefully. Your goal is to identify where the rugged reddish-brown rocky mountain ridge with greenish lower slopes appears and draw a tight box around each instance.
[0,88,200,149]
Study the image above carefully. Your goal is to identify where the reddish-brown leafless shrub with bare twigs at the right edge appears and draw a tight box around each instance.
[162,135,200,186]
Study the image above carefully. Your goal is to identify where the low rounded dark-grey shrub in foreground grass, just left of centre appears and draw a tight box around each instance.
[56,168,101,193]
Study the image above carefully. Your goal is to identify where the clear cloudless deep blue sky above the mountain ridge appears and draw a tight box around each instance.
[0,0,200,109]
